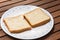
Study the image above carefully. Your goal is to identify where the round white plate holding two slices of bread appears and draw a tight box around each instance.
[1,5,54,39]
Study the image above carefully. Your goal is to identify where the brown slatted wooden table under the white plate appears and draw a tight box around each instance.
[0,0,60,40]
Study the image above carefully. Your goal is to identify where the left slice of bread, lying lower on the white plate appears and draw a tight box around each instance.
[4,16,31,33]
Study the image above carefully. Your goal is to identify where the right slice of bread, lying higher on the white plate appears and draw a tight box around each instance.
[24,8,50,27]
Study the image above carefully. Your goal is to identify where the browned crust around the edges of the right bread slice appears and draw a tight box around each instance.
[24,8,50,27]
